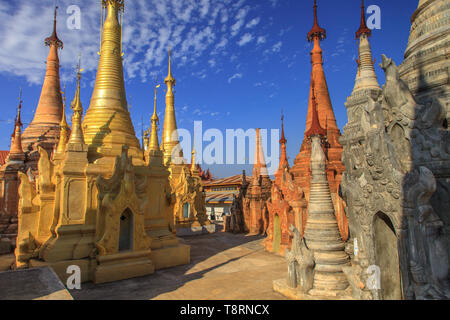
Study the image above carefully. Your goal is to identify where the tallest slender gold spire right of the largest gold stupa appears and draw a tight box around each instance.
[161,49,183,164]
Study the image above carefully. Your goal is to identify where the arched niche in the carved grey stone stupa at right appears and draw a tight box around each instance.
[373,212,402,300]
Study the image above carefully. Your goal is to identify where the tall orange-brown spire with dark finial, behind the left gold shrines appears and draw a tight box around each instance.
[22,7,63,169]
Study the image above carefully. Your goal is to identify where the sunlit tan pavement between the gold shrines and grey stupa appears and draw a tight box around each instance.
[70,232,287,300]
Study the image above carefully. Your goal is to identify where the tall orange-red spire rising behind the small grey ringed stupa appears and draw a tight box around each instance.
[291,0,348,240]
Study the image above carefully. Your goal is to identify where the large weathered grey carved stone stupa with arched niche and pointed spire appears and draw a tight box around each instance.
[340,1,450,300]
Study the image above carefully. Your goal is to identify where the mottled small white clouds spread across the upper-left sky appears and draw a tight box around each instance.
[0,0,259,84]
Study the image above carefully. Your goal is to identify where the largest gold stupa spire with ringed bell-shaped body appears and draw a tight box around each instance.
[83,0,143,160]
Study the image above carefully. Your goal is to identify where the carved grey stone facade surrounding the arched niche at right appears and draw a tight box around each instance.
[340,55,450,299]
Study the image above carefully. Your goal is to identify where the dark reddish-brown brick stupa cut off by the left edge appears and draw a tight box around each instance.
[0,96,25,254]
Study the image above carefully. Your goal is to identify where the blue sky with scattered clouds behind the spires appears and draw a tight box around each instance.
[0,0,418,177]
